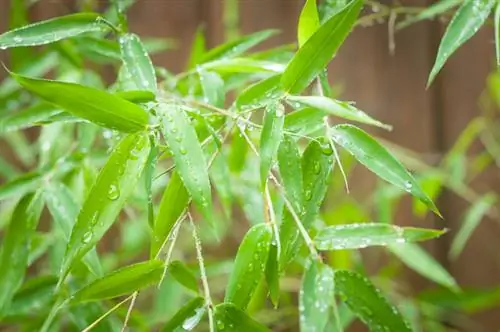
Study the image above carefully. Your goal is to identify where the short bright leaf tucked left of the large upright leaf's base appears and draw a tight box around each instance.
[235,74,283,112]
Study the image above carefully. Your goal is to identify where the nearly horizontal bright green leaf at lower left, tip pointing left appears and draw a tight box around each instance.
[70,260,164,304]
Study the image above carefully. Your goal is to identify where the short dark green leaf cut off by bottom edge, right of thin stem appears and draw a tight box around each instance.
[214,303,271,332]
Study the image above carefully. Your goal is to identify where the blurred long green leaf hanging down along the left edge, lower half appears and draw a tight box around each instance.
[0,194,42,317]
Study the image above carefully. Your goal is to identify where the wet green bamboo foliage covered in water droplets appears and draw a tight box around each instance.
[0,0,494,331]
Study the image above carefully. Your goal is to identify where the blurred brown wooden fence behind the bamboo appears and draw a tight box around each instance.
[0,0,500,332]
